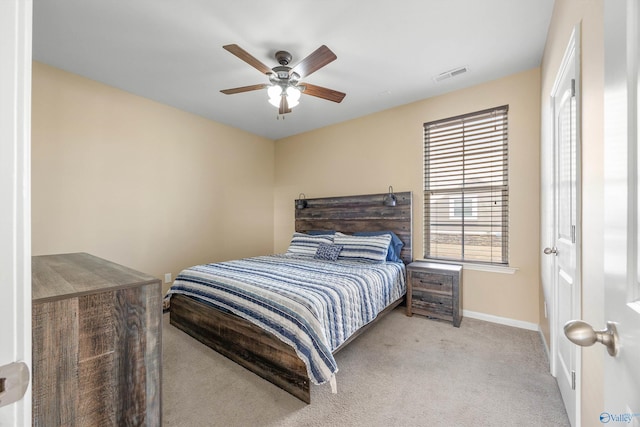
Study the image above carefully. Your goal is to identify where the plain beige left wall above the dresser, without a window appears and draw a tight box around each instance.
[32,62,274,292]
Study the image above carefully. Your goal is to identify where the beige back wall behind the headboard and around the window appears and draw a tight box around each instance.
[274,69,540,325]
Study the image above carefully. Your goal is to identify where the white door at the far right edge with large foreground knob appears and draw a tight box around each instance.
[604,0,640,420]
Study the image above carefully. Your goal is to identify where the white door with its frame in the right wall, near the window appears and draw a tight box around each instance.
[544,27,581,426]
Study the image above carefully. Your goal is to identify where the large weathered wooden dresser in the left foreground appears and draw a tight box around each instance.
[32,253,162,427]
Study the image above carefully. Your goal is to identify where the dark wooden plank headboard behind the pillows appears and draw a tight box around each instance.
[294,191,413,264]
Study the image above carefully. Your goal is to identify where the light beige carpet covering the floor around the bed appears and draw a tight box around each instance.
[163,308,569,427]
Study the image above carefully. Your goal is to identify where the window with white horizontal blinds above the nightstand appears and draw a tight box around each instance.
[424,105,509,265]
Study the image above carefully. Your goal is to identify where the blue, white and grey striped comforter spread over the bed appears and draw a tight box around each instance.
[165,254,406,384]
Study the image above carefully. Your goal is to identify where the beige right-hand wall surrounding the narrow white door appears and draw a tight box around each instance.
[541,0,605,426]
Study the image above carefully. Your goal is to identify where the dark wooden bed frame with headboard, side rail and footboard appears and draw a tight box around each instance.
[170,192,413,403]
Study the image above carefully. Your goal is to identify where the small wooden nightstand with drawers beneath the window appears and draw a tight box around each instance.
[407,261,462,327]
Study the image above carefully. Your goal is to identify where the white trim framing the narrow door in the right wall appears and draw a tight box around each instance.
[541,23,582,426]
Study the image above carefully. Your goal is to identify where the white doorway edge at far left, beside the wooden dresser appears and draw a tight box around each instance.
[0,0,32,427]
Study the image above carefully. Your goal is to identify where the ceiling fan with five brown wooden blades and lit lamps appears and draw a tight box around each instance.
[220,44,346,114]
